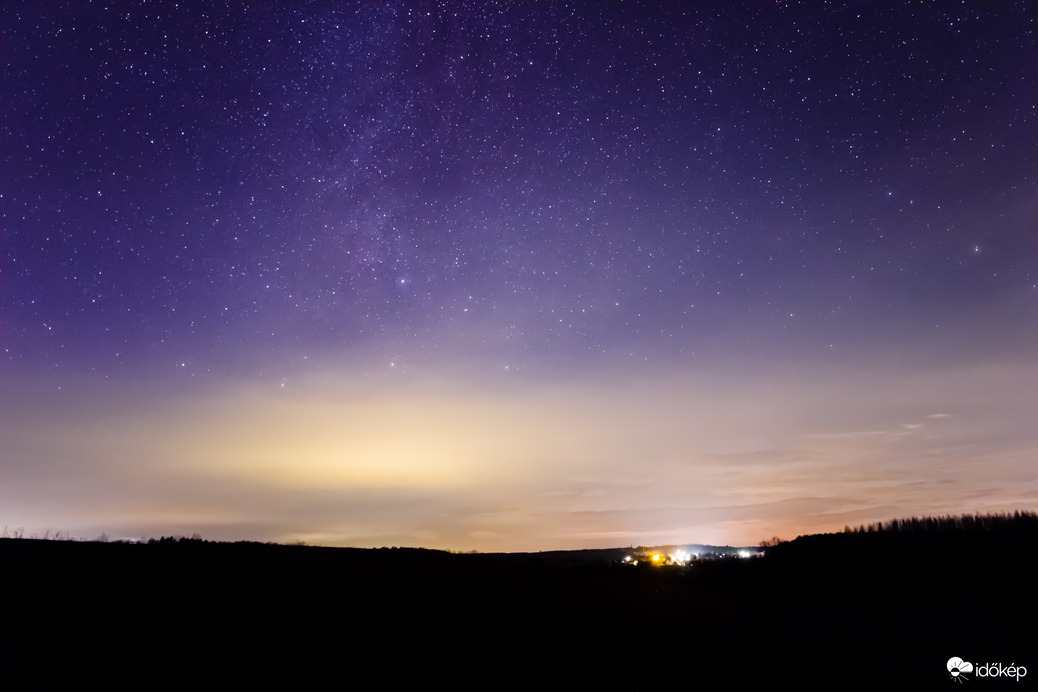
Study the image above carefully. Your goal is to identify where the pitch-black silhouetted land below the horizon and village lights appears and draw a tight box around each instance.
[0,518,1038,690]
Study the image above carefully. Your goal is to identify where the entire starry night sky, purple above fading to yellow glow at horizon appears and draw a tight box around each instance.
[0,0,1038,551]
